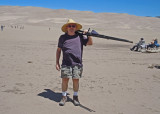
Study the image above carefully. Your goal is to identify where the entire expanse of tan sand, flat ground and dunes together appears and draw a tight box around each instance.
[0,6,160,114]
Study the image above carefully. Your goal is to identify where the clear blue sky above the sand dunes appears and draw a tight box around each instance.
[0,0,160,17]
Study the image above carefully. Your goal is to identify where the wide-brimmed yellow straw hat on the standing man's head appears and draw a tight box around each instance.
[61,19,82,32]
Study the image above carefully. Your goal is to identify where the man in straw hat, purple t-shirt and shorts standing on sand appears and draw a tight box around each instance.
[56,19,93,106]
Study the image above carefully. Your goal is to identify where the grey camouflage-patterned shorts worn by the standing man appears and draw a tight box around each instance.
[61,65,83,79]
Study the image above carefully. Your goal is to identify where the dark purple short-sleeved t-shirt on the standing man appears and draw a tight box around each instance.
[58,34,88,66]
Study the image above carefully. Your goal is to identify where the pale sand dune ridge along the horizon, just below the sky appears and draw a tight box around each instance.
[0,6,160,29]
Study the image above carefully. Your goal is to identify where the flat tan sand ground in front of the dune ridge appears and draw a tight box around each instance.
[0,6,160,114]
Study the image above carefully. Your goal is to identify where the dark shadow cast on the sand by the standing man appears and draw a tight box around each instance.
[38,89,95,112]
